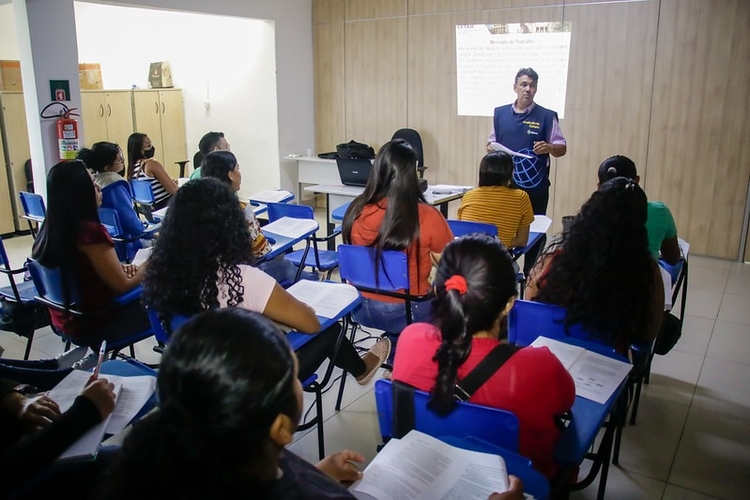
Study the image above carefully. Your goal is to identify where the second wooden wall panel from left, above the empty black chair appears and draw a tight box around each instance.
[342,17,408,150]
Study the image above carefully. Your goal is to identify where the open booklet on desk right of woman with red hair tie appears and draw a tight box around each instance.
[531,337,632,404]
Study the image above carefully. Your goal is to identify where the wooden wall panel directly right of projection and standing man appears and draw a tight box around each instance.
[556,1,659,230]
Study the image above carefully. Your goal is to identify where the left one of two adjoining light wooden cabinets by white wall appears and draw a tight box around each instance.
[81,90,135,151]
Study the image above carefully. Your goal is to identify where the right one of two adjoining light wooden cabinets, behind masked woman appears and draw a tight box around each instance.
[133,89,188,179]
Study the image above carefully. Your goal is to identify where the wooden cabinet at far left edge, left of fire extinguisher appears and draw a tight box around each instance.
[0,92,31,233]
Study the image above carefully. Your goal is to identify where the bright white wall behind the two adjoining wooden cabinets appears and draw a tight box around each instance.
[76,2,279,201]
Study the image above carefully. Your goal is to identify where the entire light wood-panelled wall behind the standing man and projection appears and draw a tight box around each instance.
[313,0,750,259]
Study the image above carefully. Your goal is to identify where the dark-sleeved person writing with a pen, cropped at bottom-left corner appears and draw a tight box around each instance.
[0,377,115,498]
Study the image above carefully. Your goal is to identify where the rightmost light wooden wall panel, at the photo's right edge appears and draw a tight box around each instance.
[646,0,750,258]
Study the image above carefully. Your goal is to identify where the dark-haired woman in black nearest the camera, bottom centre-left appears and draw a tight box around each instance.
[102,310,364,499]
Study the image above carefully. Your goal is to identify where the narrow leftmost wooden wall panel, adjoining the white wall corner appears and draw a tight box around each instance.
[313,23,346,152]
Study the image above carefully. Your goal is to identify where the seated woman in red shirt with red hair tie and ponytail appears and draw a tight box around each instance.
[393,234,575,478]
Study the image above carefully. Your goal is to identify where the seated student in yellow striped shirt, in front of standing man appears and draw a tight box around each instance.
[458,151,534,248]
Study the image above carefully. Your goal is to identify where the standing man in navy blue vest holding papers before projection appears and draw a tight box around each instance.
[487,68,568,214]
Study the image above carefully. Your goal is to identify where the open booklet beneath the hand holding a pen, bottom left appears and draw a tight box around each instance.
[47,370,156,460]
